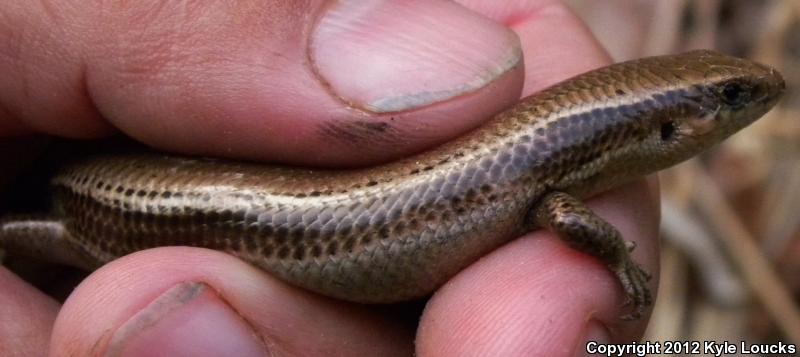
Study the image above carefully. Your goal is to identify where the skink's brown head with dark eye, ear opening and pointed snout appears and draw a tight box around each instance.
[642,50,785,165]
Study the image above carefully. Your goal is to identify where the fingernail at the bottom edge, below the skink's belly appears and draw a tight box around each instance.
[106,282,267,356]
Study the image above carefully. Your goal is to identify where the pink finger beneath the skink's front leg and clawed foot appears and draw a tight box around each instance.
[417,178,658,356]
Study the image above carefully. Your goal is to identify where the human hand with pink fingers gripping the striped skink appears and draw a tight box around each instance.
[0,0,657,356]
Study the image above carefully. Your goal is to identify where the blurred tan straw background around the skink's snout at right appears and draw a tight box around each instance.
[567,0,800,346]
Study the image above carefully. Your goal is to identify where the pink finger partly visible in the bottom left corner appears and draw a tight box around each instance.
[0,266,59,356]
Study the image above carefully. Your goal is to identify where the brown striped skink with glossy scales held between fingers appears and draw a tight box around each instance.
[0,50,784,318]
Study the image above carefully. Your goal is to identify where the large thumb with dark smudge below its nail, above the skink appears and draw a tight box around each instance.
[0,0,523,165]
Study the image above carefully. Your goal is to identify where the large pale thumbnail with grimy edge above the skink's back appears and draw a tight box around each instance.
[309,0,522,113]
